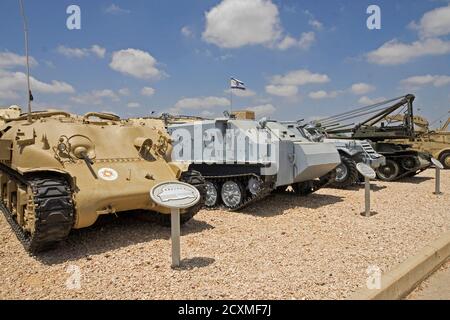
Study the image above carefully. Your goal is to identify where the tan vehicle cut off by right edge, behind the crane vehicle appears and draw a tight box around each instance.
[388,115,450,169]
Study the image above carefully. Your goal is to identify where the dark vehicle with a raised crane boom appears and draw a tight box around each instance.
[317,94,431,181]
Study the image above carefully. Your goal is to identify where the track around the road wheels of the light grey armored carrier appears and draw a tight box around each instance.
[205,174,274,212]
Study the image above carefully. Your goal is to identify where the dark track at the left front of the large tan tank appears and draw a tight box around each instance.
[0,168,74,254]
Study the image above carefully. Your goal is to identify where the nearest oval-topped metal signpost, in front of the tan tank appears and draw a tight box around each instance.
[150,181,200,267]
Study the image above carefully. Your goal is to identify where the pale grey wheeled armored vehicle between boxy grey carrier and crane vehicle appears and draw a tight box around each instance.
[283,121,386,189]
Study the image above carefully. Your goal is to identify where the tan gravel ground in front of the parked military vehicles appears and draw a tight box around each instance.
[0,170,450,299]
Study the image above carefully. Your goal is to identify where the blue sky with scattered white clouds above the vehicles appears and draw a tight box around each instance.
[0,0,450,127]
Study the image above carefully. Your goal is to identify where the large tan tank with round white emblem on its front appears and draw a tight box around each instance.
[0,109,204,253]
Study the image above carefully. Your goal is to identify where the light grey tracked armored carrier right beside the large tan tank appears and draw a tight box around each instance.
[168,112,340,210]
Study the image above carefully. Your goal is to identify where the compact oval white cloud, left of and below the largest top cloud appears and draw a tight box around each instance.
[109,49,162,79]
